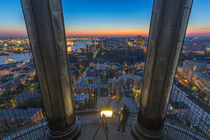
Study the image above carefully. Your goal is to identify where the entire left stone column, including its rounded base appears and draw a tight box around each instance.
[21,0,81,140]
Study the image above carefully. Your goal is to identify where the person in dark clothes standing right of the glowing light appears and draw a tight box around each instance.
[117,105,130,133]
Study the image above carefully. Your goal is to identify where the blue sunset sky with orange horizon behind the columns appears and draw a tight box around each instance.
[0,0,210,36]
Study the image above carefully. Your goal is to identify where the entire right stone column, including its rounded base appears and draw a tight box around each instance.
[132,0,193,140]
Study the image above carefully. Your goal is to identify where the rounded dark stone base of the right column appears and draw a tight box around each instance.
[131,120,164,140]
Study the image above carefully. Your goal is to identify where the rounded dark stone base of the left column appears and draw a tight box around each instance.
[48,116,81,140]
